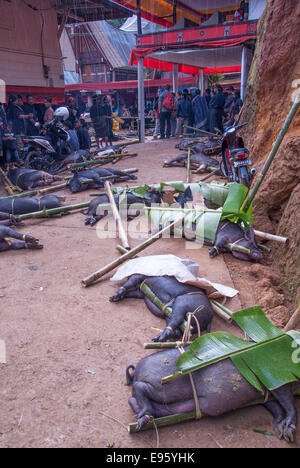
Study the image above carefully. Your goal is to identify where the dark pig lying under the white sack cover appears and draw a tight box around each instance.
[110,275,213,342]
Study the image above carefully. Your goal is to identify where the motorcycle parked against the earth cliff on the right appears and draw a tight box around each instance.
[220,122,256,187]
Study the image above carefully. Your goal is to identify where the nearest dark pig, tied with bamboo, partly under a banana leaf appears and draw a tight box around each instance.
[126,349,299,442]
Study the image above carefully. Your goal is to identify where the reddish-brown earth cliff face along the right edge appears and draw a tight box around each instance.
[242,0,300,300]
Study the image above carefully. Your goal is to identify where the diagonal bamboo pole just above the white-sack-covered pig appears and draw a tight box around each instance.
[82,214,190,287]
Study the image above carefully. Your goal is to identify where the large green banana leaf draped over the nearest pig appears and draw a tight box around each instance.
[163,307,300,393]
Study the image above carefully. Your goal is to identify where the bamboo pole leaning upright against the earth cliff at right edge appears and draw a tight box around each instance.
[243,93,300,213]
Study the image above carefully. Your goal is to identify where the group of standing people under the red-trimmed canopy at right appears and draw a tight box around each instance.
[154,84,243,139]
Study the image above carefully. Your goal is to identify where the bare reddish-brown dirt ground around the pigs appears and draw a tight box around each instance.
[0,139,300,448]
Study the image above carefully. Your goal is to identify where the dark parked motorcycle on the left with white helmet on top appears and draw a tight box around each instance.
[21,108,71,174]
